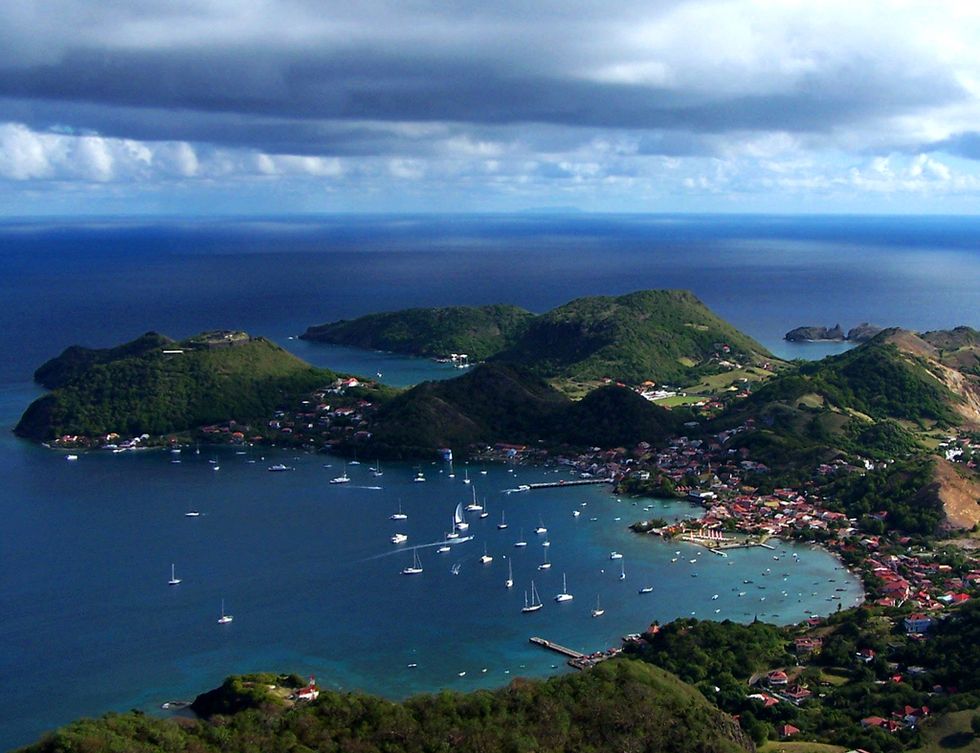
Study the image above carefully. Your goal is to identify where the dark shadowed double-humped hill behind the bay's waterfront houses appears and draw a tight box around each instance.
[356,363,685,457]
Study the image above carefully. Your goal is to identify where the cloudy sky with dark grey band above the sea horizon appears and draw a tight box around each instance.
[0,0,980,217]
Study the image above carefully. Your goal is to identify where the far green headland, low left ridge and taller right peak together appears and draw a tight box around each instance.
[303,290,772,387]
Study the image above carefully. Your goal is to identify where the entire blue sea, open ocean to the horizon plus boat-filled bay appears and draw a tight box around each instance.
[0,215,980,749]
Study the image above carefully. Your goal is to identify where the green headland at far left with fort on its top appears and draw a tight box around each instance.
[15,333,336,440]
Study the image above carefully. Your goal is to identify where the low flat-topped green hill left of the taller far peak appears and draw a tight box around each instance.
[301,305,534,361]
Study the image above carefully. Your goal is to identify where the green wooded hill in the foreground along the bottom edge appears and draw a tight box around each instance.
[21,659,754,753]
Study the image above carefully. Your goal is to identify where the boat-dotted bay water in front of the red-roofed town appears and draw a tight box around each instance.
[0,394,860,745]
